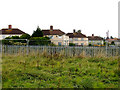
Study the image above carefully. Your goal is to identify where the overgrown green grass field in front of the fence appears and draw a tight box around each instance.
[2,54,120,88]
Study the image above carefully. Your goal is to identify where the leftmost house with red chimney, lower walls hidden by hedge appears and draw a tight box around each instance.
[0,25,26,39]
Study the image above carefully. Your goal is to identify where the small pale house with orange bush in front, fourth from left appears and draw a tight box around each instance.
[88,34,104,45]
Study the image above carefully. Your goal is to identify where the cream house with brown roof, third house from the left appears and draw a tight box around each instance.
[66,29,88,46]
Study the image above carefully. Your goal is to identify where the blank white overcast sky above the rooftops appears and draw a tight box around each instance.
[0,0,119,37]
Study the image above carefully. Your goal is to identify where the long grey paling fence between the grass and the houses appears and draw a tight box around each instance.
[2,45,120,56]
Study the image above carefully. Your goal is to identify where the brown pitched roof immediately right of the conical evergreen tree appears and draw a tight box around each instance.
[42,29,65,35]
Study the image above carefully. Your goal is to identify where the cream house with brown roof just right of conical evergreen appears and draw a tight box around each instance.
[42,25,69,45]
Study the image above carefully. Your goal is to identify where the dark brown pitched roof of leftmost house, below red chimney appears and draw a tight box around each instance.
[0,28,26,35]
